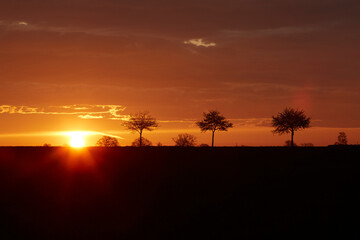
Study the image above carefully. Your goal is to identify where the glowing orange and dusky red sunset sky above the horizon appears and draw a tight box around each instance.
[0,0,360,146]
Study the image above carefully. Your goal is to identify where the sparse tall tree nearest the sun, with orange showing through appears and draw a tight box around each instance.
[123,112,158,147]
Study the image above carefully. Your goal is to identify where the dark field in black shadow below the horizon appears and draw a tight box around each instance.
[0,147,360,239]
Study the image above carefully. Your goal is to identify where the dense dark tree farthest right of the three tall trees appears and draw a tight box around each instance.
[272,108,310,147]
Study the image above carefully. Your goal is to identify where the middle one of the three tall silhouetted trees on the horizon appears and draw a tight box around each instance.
[196,110,233,147]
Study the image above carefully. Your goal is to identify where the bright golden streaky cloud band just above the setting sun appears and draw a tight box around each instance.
[0,105,129,120]
